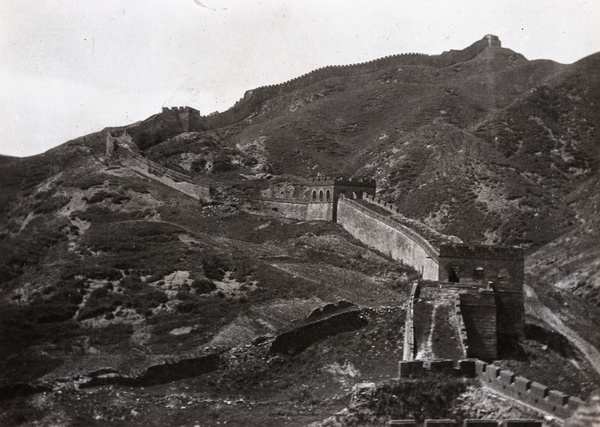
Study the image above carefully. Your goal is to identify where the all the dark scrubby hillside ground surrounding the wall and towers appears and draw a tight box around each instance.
[0,39,600,425]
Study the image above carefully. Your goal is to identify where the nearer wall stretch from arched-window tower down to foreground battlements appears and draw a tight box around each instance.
[246,178,582,426]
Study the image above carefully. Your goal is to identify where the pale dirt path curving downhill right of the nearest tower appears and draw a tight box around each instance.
[525,285,600,373]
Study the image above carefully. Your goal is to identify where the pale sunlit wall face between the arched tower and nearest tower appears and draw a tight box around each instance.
[337,197,439,280]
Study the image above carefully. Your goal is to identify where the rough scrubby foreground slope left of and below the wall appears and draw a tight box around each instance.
[0,145,420,425]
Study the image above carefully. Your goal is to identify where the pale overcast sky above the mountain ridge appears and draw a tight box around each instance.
[0,0,600,156]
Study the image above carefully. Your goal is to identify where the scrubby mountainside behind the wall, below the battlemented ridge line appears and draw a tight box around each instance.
[147,38,600,251]
